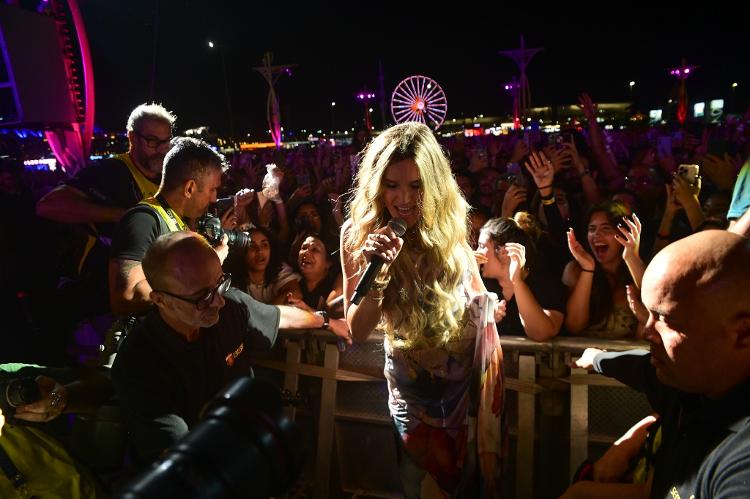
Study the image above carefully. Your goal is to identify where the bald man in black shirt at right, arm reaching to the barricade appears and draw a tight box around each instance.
[577,230,750,498]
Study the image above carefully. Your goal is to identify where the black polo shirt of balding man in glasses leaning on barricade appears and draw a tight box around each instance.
[112,288,280,463]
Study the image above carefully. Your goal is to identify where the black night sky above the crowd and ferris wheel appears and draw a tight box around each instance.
[79,0,750,139]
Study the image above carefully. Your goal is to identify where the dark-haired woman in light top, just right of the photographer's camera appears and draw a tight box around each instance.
[226,227,302,305]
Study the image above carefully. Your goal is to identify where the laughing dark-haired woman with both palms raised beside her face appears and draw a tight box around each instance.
[563,201,646,338]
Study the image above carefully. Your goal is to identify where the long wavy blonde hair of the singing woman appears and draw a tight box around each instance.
[344,123,473,348]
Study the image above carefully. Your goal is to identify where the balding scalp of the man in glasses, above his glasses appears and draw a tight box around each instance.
[142,231,219,289]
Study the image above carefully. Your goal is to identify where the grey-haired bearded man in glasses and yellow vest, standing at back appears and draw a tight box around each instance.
[36,104,176,319]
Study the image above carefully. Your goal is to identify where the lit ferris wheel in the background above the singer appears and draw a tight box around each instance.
[391,75,448,130]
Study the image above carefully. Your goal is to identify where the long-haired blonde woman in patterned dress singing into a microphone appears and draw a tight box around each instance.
[341,123,503,498]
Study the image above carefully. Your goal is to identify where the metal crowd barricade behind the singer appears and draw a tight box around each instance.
[255,330,649,499]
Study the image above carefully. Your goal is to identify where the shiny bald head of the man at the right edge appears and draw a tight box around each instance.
[641,230,750,398]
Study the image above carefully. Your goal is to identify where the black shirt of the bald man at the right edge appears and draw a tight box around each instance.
[594,350,750,499]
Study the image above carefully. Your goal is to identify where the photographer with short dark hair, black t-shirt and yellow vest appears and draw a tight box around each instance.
[109,137,231,316]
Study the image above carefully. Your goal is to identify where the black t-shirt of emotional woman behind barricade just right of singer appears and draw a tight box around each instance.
[482,271,565,336]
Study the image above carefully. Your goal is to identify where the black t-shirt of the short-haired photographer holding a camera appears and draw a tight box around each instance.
[110,204,170,262]
